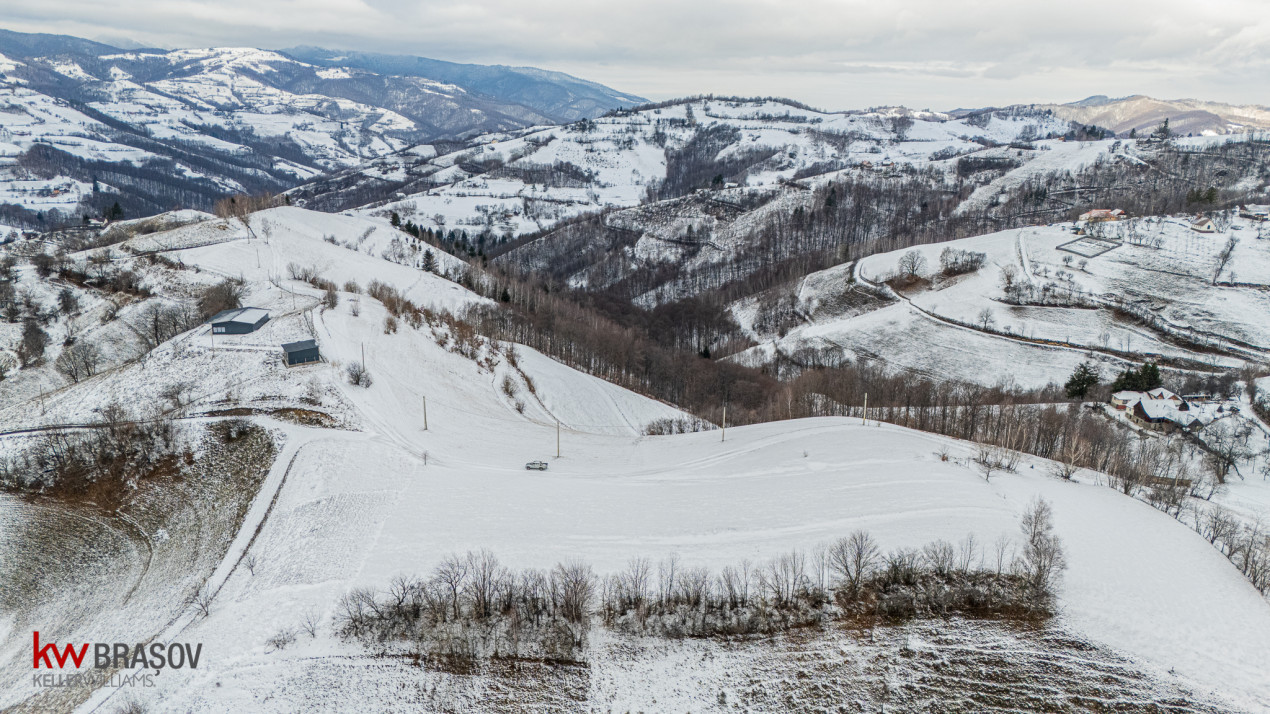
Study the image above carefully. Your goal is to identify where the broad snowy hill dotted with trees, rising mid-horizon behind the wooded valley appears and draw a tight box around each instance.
[304,99,1069,236]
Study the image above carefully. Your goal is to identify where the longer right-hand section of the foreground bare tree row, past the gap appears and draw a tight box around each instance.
[599,501,1066,637]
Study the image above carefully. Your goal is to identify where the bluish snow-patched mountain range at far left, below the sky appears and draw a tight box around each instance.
[0,30,644,226]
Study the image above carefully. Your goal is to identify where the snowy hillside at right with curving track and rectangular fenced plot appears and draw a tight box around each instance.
[734,209,1270,387]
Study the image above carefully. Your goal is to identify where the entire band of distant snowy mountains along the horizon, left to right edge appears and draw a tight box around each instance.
[0,24,1270,235]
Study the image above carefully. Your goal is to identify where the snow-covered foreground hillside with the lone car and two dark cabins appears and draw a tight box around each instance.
[0,207,1270,711]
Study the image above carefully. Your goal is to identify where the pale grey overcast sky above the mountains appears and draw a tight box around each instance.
[0,0,1270,109]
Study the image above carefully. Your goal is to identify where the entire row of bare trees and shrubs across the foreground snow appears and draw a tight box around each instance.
[334,499,1064,670]
